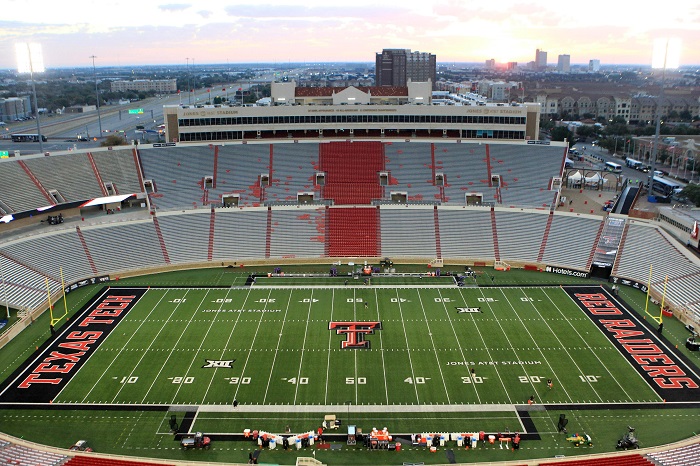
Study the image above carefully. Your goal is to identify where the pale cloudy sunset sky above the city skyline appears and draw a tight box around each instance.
[0,0,700,69]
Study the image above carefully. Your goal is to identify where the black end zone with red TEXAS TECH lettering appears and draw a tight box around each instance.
[0,288,146,403]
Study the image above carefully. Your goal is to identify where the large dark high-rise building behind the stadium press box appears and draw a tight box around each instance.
[375,49,437,88]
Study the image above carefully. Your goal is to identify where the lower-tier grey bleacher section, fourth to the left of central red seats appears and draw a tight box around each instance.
[80,219,165,274]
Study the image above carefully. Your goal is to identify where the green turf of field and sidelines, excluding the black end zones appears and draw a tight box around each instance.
[0,266,700,464]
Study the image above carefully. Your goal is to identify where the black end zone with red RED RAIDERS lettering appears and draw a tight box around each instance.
[563,286,700,402]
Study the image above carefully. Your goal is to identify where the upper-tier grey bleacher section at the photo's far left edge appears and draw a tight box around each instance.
[0,159,51,212]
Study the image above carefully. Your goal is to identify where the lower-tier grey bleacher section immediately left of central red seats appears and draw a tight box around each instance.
[270,207,326,258]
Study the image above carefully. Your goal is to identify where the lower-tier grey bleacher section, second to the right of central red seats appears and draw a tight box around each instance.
[438,208,495,261]
